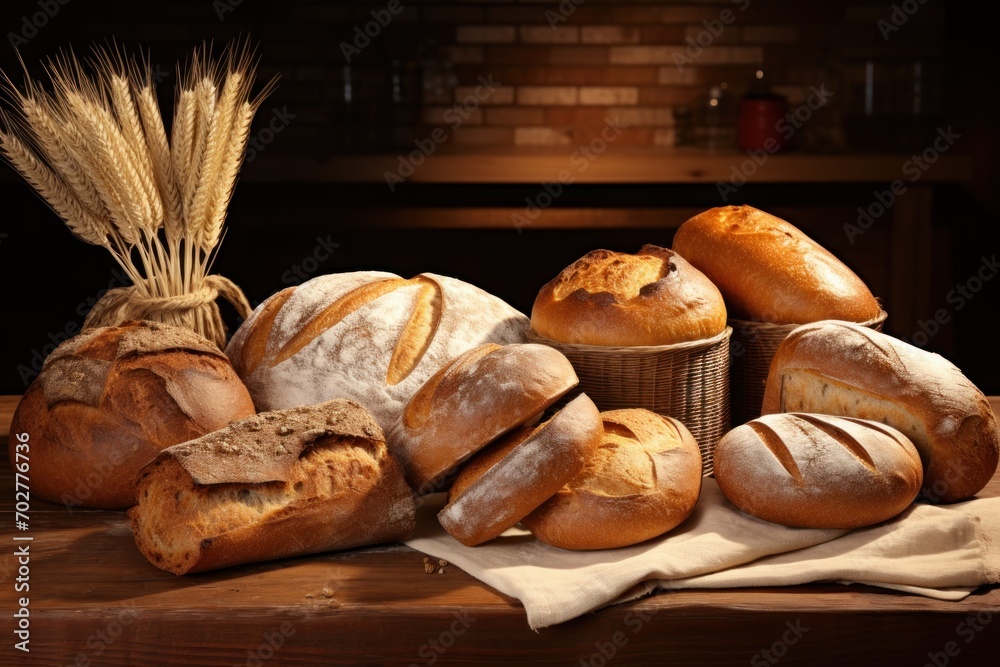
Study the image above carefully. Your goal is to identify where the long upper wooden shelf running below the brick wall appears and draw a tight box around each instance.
[242,147,972,184]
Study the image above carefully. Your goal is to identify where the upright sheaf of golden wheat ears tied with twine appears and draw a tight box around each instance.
[0,41,275,348]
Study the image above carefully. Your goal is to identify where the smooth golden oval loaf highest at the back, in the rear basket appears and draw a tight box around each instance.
[673,206,881,324]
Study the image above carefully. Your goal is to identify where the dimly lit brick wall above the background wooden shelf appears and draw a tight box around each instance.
[0,0,944,157]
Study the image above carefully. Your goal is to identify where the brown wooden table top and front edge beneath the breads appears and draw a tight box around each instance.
[0,397,1000,667]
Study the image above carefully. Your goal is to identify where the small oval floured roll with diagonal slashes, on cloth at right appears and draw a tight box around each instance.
[715,413,923,528]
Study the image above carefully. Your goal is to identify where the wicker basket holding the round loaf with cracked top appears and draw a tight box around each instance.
[528,327,733,475]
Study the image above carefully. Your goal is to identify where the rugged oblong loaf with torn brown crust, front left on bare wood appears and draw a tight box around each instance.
[129,400,415,574]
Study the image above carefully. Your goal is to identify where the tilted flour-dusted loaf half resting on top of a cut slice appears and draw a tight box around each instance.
[390,343,578,493]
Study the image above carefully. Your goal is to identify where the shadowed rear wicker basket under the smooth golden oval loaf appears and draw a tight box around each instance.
[729,310,886,426]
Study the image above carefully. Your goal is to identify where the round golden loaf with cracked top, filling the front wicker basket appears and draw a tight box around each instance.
[531,245,726,346]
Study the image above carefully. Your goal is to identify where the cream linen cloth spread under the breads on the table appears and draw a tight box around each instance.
[407,478,1000,629]
